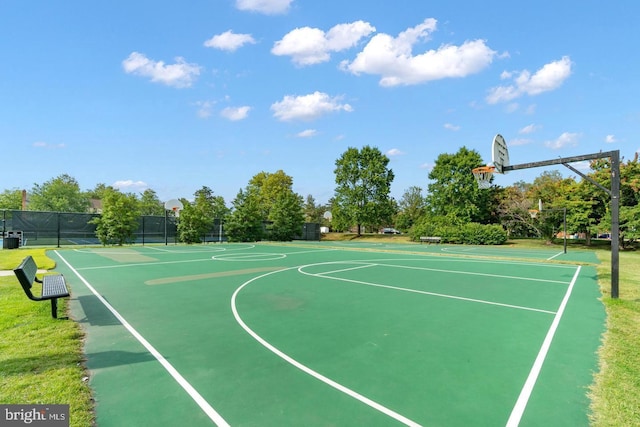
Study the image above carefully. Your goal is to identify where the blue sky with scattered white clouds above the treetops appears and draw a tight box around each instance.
[0,0,640,203]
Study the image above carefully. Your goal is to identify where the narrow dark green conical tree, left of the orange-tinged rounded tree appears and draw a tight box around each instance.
[226,189,263,242]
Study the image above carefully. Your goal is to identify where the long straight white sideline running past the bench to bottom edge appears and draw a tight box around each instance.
[54,251,229,427]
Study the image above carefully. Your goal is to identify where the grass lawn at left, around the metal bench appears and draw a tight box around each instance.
[0,249,94,427]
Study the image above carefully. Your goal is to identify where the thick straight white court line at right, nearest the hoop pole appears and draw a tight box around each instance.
[507,266,582,427]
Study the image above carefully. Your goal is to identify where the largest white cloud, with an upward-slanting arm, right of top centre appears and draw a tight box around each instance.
[341,18,496,86]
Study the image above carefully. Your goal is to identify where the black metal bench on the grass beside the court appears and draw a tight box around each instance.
[13,255,69,319]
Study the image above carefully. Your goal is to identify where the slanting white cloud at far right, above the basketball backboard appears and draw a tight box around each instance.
[486,56,572,104]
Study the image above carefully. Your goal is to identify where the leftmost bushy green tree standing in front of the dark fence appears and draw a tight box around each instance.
[90,190,140,246]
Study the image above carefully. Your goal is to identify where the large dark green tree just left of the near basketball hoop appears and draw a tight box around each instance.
[427,147,484,224]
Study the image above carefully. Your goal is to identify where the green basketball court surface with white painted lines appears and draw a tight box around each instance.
[51,242,605,426]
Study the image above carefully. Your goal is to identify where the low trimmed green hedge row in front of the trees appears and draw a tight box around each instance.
[411,221,507,245]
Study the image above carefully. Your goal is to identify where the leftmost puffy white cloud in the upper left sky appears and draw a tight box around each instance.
[122,52,200,88]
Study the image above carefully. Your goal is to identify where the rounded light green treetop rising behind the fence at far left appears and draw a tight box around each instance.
[29,174,89,212]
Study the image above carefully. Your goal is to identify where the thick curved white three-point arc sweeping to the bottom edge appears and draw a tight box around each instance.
[231,267,420,427]
